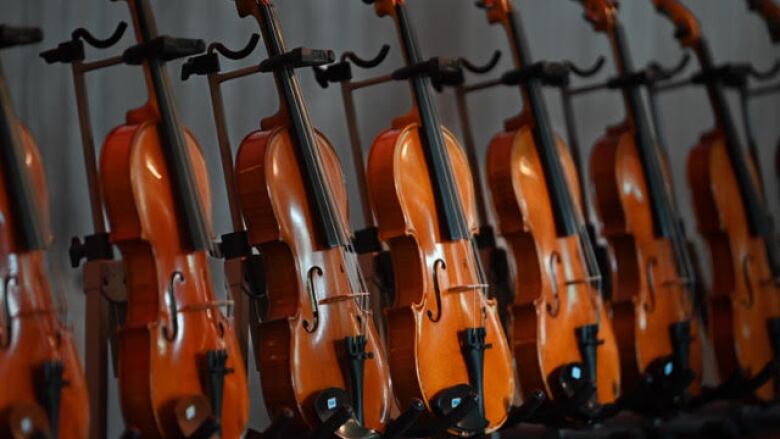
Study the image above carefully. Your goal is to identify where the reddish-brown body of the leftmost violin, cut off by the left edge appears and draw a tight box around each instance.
[0,124,89,439]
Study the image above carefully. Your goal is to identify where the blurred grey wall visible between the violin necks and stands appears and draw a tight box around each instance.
[0,0,780,437]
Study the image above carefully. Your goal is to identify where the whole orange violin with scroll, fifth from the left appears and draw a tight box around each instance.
[481,0,621,418]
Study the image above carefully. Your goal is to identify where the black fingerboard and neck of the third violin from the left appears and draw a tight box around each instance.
[256,2,350,248]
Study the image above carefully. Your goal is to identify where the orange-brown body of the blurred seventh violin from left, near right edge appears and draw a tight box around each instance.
[688,131,780,401]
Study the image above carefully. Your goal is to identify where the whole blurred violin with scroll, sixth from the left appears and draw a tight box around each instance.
[568,0,702,412]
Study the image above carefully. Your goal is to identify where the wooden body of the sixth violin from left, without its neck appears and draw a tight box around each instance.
[590,124,702,393]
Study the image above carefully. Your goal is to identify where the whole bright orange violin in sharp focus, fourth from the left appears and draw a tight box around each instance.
[367,0,515,436]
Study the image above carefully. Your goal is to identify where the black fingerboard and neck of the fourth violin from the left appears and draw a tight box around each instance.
[395,3,471,241]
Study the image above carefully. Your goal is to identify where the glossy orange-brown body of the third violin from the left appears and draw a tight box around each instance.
[235,125,395,431]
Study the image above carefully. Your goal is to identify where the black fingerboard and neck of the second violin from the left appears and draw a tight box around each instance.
[131,0,213,251]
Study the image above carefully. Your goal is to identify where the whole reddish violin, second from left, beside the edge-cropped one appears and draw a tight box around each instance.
[100,0,249,438]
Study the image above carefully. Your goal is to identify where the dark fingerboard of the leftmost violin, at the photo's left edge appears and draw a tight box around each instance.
[0,59,46,251]
